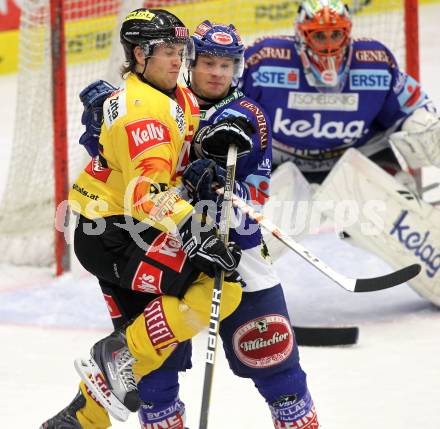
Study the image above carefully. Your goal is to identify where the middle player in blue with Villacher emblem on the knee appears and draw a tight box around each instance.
[39,21,319,429]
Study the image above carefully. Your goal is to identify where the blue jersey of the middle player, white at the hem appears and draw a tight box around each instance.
[200,90,279,292]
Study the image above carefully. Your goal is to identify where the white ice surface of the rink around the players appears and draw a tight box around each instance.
[0,4,440,429]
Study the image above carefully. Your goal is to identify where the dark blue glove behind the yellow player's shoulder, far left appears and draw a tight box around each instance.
[79,80,117,157]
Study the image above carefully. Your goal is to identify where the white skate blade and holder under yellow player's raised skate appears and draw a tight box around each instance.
[75,358,130,422]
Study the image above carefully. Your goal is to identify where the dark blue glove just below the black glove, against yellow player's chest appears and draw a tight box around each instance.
[182,159,226,205]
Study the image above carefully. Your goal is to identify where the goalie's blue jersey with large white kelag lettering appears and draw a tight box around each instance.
[241,37,430,173]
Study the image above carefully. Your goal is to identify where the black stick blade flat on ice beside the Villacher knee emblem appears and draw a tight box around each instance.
[293,326,359,347]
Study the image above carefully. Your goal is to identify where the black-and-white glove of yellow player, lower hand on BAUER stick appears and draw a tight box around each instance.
[179,215,241,281]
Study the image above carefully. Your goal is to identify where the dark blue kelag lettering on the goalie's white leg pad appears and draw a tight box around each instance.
[390,210,440,278]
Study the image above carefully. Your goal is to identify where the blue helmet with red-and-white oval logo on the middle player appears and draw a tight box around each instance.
[190,20,244,79]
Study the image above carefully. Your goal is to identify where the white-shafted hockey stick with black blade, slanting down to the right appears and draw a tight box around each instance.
[217,189,422,292]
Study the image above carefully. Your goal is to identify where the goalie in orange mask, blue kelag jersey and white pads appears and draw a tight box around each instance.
[241,0,440,305]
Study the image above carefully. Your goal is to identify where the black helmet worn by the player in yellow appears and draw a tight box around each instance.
[120,8,194,62]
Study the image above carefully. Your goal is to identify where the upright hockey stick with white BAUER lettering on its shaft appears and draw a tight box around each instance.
[199,145,237,429]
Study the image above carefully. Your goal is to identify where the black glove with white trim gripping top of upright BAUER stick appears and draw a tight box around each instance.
[194,116,256,166]
